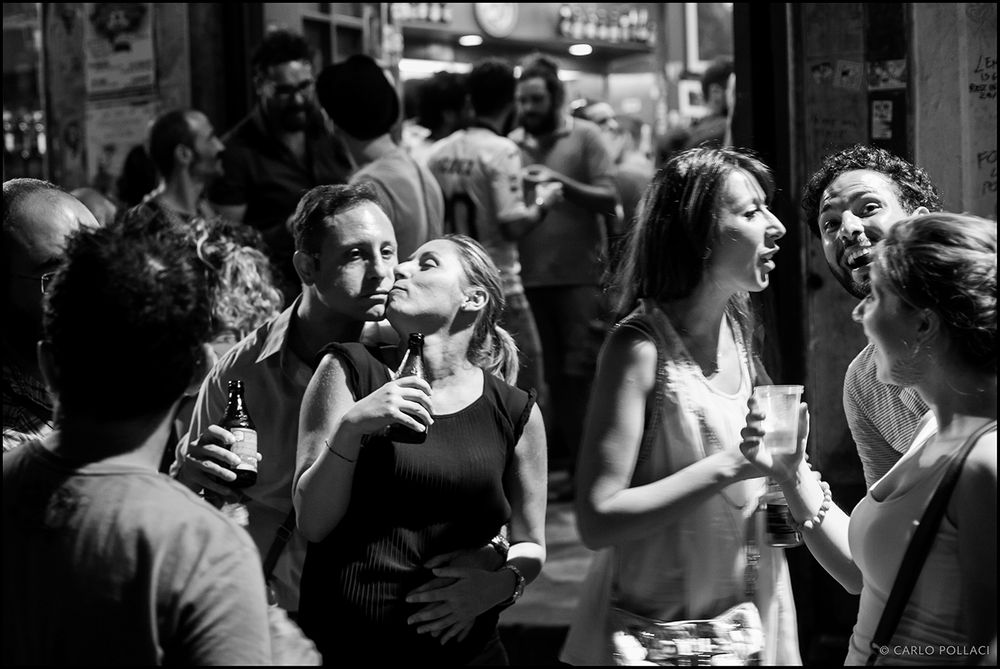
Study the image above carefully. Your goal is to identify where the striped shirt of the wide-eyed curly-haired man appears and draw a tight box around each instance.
[844,344,930,488]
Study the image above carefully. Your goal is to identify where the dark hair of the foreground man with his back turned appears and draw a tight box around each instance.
[43,218,211,419]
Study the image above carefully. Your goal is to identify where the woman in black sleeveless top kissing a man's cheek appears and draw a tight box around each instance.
[293,235,547,664]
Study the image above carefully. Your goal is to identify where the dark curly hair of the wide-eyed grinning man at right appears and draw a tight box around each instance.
[802,144,942,236]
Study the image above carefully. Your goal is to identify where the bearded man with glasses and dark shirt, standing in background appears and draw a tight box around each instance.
[208,30,351,302]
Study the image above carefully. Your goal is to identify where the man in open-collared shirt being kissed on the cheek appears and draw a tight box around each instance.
[171,185,396,614]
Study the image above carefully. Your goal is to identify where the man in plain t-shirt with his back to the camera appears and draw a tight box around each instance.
[3,218,273,666]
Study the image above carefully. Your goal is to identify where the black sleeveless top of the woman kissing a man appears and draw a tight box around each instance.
[299,343,535,664]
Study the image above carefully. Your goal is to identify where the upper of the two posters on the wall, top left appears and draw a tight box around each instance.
[83,2,156,98]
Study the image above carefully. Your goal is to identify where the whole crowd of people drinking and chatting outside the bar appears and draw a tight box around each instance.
[2,31,997,665]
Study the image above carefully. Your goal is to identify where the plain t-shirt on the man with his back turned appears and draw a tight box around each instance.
[0,435,271,666]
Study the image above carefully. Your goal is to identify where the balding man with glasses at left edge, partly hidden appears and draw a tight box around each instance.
[0,179,99,452]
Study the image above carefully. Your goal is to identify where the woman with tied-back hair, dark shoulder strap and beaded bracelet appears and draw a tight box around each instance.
[741,213,997,665]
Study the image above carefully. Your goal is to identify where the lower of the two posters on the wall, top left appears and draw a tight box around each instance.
[87,98,158,193]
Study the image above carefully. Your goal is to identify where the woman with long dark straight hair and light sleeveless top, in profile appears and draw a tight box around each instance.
[560,149,801,665]
